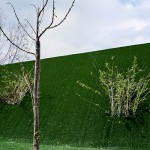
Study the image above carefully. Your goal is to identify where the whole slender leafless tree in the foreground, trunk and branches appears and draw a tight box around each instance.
[0,0,75,150]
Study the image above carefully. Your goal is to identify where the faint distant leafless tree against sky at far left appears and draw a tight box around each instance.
[0,12,31,65]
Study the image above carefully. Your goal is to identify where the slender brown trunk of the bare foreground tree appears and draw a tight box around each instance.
[33,40,40,150]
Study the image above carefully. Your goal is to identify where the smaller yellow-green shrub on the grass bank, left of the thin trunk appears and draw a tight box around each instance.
[0,68,33,104]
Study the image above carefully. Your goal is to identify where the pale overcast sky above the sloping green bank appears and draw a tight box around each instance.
[0,0,150,58]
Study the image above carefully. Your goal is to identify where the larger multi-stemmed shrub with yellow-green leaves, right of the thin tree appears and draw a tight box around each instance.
[77,57,150,117]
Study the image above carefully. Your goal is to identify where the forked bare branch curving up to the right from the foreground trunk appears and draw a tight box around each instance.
[39,0,75,37]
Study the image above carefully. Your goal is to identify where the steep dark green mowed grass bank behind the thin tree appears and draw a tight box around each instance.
[0,44,150,150]
